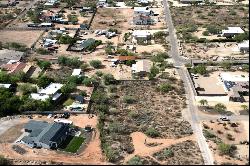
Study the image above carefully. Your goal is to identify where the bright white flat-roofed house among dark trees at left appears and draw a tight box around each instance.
[31,83,63,101]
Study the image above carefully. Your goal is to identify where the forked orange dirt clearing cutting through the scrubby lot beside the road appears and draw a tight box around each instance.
[125,132,195,162]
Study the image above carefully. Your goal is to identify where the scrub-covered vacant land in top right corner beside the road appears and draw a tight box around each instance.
[171,5,249,41]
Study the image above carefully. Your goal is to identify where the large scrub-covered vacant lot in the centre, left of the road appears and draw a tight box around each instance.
[92,79,192,163]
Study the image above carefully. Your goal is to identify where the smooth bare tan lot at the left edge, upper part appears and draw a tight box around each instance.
[0,30,43,47]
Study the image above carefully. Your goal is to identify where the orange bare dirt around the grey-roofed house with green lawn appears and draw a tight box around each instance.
[0,115,107,164]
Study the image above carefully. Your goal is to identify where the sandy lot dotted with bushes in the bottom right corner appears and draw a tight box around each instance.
[203,121,249,165]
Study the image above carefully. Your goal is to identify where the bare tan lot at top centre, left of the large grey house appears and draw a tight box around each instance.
[91,8,133,31]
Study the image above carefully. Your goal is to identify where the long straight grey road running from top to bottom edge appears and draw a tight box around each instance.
[163,0,214,165]
